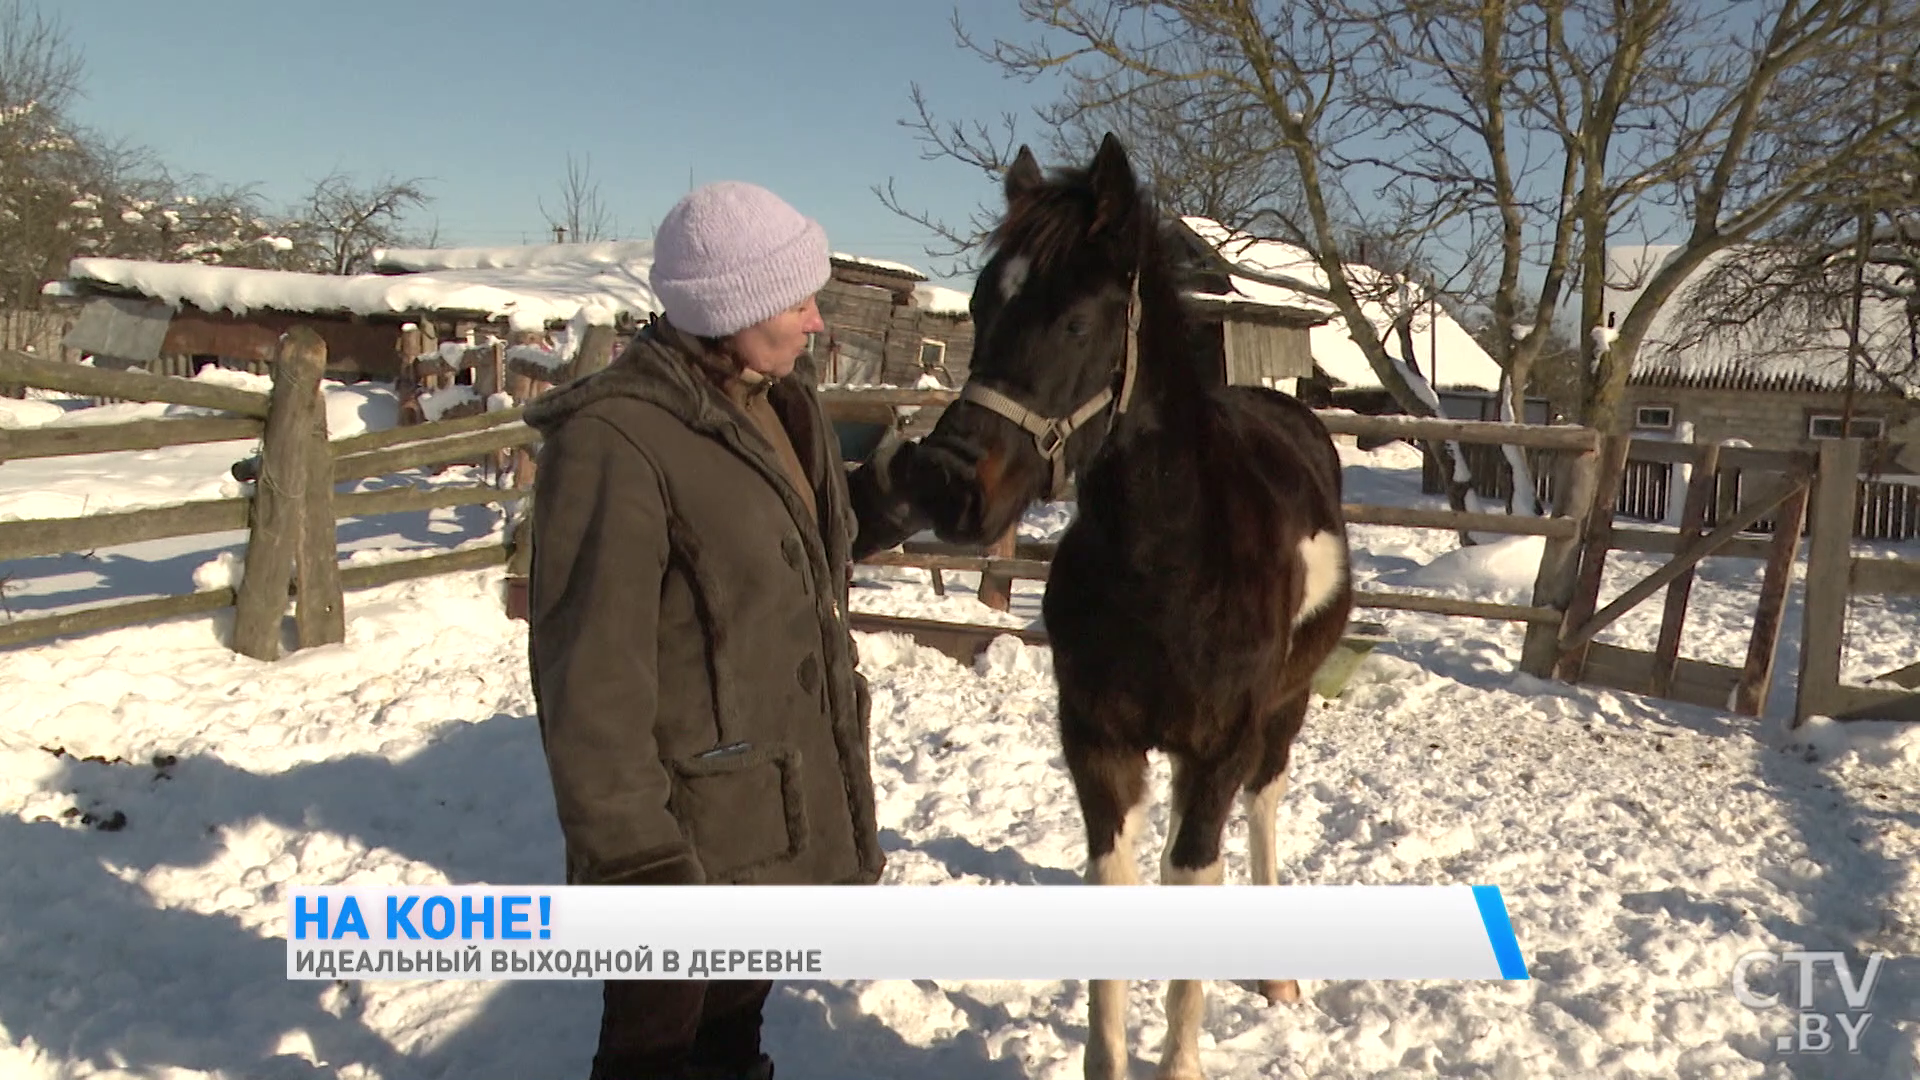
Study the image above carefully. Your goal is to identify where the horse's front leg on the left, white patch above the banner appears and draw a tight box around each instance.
[1062,726,1146,1080]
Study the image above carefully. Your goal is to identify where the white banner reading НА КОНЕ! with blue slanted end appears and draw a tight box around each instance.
[286,884,1526,982]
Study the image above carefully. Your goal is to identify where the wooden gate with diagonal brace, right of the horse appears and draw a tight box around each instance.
[1555,428,1812,717]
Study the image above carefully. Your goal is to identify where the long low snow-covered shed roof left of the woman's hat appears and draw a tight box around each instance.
[48,242,660,331]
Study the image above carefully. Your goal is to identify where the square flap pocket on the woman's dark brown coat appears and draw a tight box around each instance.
[670,742,806,880]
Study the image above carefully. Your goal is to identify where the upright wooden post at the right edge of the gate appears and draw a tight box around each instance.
[1793,438,1860,726]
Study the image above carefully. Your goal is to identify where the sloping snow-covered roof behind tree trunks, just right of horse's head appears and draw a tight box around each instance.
[1181,217,1500,390]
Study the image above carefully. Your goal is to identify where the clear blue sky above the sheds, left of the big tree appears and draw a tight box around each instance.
[56,0,1067,286]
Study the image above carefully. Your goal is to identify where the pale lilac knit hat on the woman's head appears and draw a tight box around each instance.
[651,181,833,338]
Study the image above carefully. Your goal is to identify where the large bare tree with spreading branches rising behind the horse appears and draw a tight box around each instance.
[893,0,1920,449]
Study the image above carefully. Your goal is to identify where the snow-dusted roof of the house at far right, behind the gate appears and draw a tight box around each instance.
[1605,244,1920,394]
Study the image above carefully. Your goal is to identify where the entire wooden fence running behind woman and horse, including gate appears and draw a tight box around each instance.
[0,365,1920,719]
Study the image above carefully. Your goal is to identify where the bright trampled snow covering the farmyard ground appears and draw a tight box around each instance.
[0,388,1920,1080]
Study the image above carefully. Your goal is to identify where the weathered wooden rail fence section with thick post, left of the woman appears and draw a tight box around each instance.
[0,340,540,659]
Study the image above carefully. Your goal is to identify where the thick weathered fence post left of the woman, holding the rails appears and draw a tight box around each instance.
[232,327,340,661]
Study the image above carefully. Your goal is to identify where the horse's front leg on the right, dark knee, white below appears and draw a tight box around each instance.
[1160,757,1244,1080]
